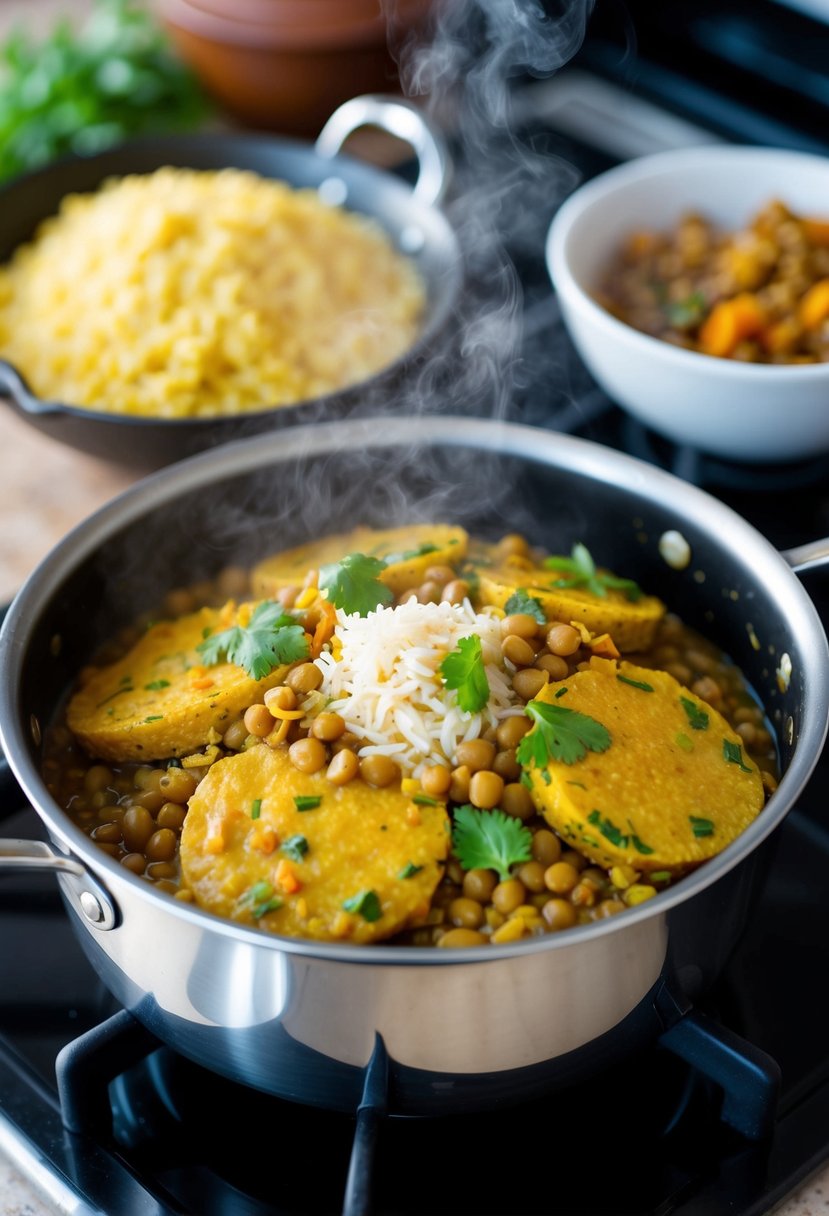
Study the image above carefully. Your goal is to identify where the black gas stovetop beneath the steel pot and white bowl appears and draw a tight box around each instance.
[0,2,829,1216]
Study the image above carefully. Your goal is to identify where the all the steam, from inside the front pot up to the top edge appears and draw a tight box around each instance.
[88,0,590,622]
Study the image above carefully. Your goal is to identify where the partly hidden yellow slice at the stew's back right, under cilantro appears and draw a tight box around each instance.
[478,558,665,652]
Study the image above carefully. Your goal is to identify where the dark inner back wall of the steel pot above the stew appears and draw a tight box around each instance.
[19,420,827,802]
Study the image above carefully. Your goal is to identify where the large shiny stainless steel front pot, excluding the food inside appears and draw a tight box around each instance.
[0,417,829,1113]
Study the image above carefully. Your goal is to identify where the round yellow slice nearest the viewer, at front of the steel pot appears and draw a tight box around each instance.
[181,744,450,942]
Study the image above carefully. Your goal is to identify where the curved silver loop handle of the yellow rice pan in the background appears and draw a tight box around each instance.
[314,94,451,207]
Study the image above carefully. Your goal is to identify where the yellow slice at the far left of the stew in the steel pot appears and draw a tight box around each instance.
[67,603,294,760]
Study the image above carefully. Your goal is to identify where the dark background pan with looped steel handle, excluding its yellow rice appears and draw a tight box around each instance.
[0,96,454,472]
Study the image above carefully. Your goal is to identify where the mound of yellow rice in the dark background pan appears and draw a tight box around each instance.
[0,168,424,418]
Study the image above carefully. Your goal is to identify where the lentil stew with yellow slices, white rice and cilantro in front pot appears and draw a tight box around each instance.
[43,524,778,947]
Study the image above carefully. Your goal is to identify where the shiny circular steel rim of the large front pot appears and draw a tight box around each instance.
[0,415,829,966]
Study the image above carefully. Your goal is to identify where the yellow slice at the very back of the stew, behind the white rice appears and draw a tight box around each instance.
[252,524,469,596]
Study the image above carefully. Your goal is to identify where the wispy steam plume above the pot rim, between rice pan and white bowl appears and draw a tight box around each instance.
[376,0,591,432]
